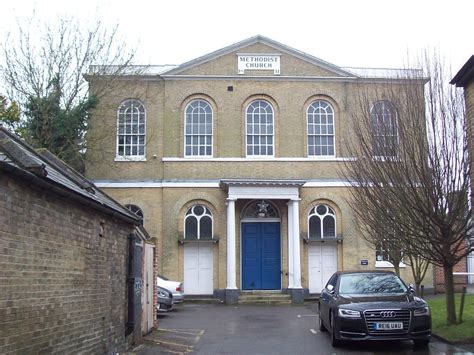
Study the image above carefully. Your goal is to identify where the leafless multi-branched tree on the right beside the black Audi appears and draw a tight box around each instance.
[341,53,471,324]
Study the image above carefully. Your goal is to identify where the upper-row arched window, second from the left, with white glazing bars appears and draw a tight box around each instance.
[184,99,212,157]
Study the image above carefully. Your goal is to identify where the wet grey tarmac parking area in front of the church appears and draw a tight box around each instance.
[133,303,474,355]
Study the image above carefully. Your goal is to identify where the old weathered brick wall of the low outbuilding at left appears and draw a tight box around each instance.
[0,174,131,354]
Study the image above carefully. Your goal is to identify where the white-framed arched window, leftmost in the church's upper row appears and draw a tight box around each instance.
[115,99,146,161]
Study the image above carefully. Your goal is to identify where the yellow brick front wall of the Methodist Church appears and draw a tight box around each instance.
[87,40,436,289]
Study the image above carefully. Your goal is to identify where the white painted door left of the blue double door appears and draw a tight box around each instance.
[183,243,214,295]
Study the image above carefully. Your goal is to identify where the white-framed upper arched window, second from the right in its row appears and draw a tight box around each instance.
[306,100,336,158]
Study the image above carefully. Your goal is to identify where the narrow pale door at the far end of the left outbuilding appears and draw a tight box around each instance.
[142,243,155,334]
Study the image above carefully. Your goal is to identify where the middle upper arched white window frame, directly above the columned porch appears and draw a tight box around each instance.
[245,99,275,158]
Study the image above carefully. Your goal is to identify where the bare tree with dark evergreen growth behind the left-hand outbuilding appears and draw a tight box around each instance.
[1,18,138,170]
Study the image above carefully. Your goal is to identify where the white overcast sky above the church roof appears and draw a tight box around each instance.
[0,0,474,73]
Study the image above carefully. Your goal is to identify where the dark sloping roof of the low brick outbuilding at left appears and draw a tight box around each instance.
[0,126,140,225]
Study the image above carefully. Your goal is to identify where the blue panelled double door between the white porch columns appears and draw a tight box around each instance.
[242,222,281,290]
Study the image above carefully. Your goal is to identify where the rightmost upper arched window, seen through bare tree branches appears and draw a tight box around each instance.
[370,100,400,161]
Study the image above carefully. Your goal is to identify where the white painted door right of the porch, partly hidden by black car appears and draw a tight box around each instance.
[308,243,337,293]
